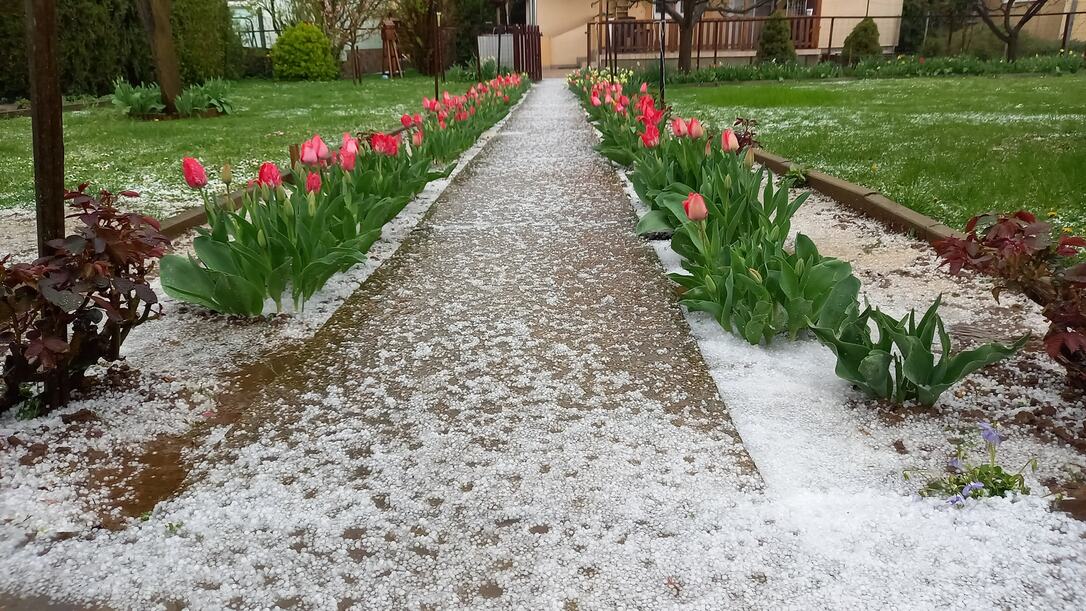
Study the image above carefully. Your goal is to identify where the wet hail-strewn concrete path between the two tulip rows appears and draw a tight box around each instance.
[6,80,761,609]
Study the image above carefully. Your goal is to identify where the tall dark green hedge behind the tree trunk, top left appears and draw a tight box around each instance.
[0,0,241,100]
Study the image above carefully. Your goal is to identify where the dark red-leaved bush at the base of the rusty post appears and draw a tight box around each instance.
[0,183,169,412]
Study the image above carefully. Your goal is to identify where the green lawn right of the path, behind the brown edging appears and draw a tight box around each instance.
[668,75,1086,230]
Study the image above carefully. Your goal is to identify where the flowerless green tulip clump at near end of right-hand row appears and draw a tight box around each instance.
[811,296,1028,406]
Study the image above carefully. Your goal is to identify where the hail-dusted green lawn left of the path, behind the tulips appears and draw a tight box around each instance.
[0,77,440,215]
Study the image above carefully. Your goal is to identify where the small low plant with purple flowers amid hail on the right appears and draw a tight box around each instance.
[905,422,1037,507]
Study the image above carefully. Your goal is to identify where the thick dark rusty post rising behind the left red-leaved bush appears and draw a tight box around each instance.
[26,0,64,256]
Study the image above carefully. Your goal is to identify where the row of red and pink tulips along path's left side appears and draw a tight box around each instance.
[162,75,526,316]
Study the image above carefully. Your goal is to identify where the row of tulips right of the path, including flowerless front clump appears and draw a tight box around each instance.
[570,71,1026,406]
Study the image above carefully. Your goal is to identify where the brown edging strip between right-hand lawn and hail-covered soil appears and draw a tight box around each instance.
[754,149,963,243]
